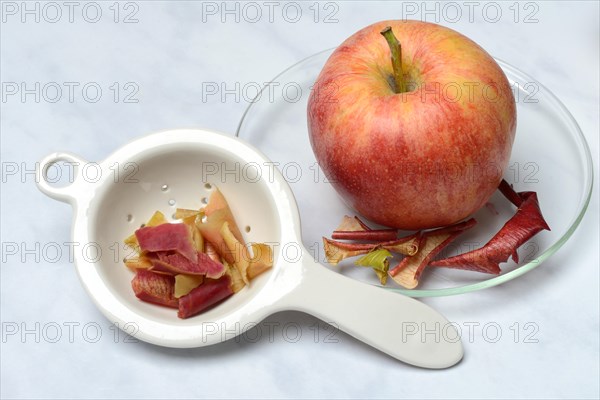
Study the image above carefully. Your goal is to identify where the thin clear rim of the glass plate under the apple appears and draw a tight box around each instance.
[235,48,594,297]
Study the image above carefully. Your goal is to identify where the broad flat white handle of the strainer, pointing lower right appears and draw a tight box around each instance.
[282,249,463,369]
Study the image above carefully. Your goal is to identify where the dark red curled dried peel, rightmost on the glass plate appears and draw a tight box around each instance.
[430,181,550,274]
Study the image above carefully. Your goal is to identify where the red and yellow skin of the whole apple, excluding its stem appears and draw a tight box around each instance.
[308,21,516,230]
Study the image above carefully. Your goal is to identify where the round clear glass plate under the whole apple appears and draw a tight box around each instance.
[236,49,592,297]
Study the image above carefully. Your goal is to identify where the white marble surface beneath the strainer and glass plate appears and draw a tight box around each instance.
[0,1,600,398]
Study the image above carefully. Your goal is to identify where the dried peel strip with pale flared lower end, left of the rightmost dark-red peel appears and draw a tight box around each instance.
[389,218,477,289]
